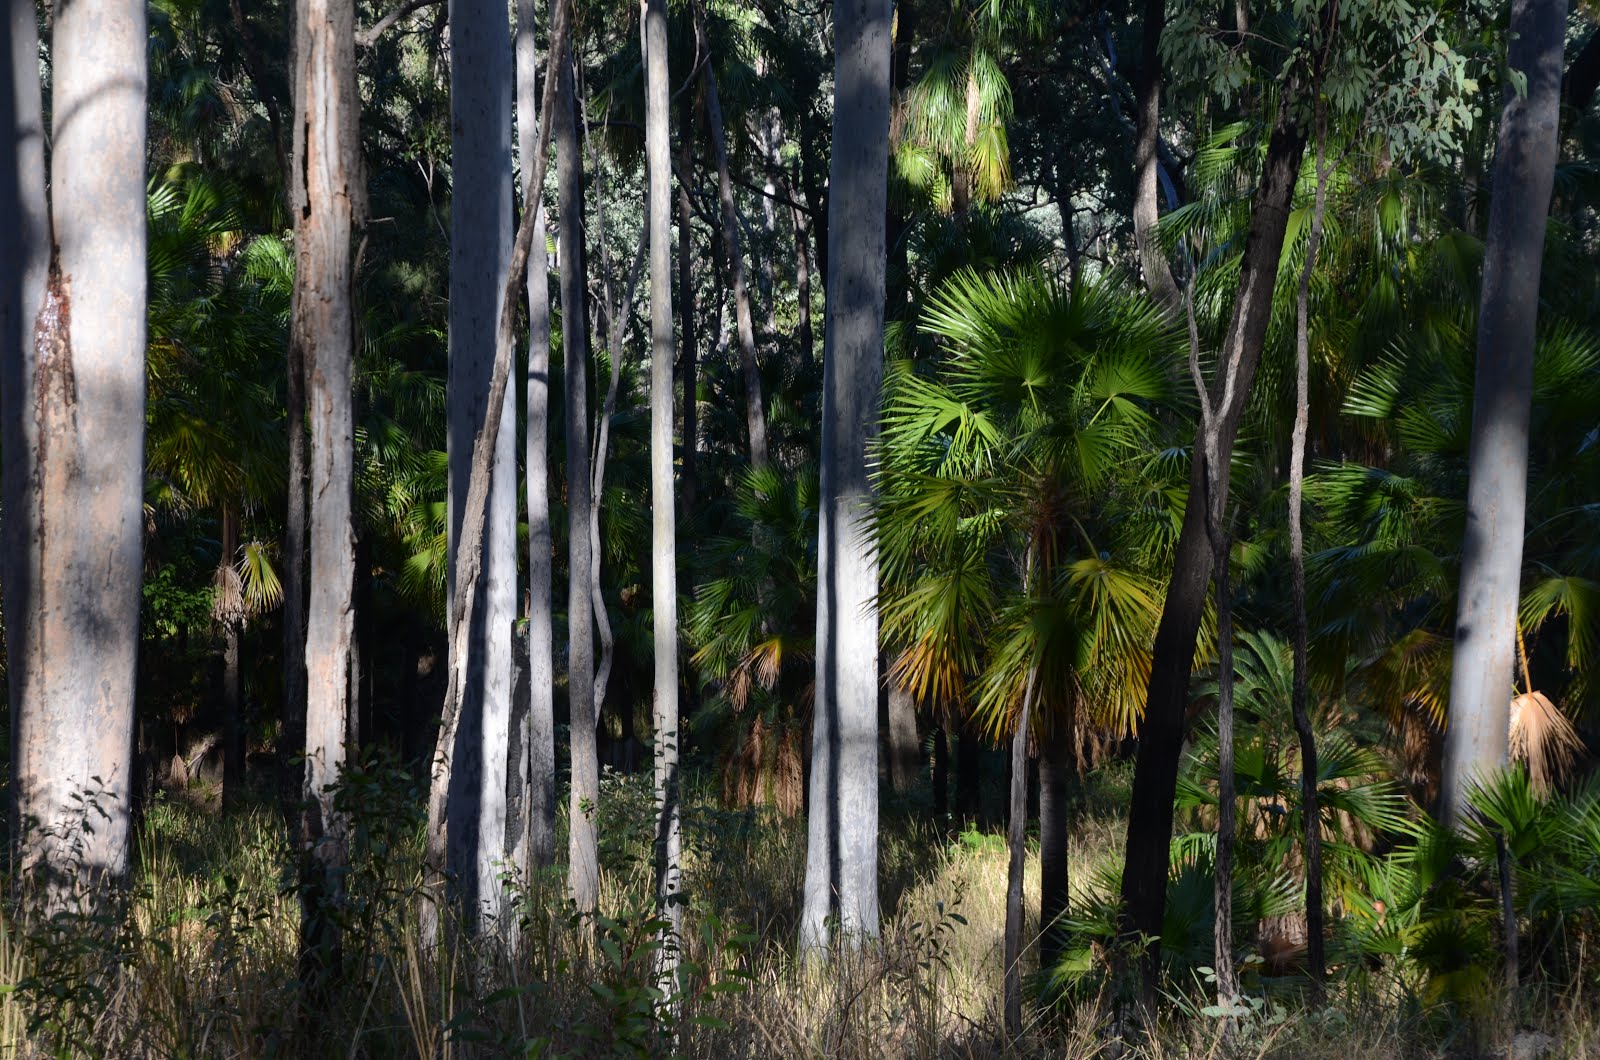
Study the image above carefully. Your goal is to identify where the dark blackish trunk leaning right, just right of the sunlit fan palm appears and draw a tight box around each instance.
[1122,101,1306,1001]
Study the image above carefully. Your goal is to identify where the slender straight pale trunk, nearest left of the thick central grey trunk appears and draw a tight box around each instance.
[640,0,683,994]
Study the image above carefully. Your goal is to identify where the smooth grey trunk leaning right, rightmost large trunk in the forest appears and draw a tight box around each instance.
[1440,0,1566,823]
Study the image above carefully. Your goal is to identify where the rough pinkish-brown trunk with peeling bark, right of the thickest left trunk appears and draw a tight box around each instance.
[290,0,365,970]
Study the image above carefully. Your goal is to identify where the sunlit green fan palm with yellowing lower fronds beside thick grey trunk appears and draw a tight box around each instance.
[877,269,1174,1023]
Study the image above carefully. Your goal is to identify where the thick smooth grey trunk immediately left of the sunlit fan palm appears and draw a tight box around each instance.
[800,0,893,954]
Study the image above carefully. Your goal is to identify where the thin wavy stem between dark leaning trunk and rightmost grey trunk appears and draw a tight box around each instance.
[1290,126,1328,1002]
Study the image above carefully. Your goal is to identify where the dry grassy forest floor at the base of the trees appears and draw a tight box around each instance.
[0,758,1600,1060]
